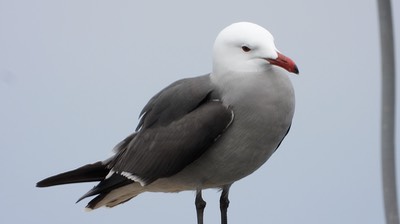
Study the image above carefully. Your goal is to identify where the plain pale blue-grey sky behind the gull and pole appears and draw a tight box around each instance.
[0,0,400,224]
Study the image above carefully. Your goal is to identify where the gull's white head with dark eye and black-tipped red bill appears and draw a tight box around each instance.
[213,22,298,74]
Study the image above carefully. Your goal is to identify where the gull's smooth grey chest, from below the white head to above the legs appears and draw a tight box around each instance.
[205,75,294,182]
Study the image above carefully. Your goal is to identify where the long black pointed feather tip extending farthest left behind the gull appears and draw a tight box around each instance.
[36,162,110,187]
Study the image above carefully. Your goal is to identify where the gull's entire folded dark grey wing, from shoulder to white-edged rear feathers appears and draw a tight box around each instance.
[110,75,233,184]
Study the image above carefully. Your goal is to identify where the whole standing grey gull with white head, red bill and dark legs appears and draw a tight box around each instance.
[37,22,298,224]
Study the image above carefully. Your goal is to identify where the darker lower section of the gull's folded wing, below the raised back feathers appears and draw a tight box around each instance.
[112,101,232,184]
